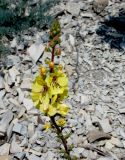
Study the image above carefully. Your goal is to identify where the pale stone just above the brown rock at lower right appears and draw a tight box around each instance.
[99,119,112,133]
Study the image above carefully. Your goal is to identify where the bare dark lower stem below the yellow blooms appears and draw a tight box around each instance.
[51,117,71,160]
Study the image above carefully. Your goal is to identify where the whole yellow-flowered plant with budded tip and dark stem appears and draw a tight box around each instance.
[31,20,71,160]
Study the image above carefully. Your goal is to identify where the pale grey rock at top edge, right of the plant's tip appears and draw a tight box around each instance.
[66,2,81,17]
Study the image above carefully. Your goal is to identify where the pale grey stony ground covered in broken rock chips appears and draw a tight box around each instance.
[0,0,125,160]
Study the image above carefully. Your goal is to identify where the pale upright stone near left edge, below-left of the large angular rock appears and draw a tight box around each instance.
[9,66,20,82]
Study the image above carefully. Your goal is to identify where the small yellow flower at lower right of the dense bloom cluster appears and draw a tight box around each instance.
[57,104,69,116]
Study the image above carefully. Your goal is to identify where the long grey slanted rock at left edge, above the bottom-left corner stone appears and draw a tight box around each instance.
[0,110,13,136]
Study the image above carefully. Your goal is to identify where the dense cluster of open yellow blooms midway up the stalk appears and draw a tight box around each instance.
[31,67,68,117]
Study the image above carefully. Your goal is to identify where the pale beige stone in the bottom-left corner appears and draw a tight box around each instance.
[0,143,10,156]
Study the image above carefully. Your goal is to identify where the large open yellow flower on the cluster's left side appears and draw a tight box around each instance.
[31,76,50,108]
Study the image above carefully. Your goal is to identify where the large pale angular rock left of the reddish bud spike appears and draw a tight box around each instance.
[27,43,45,62]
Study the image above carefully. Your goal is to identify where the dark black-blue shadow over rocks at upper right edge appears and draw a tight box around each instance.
[96,12,125,51]
